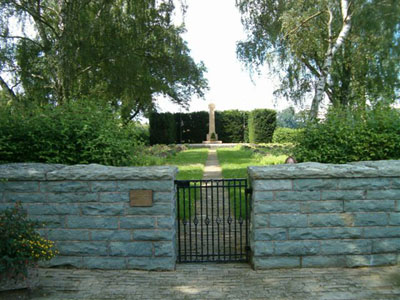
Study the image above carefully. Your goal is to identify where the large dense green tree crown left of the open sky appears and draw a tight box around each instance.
[0,0,207,120]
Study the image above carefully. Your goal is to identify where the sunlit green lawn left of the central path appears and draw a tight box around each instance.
[165,148,208,180]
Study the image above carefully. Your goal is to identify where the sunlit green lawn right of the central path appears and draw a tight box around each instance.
[217,146,288,178]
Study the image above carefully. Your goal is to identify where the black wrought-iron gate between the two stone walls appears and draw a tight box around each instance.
[175,179,250,262]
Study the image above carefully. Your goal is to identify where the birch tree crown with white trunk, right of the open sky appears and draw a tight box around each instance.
[236,0,400,118]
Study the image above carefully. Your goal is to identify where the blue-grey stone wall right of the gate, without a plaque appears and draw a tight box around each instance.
[249,161,400,269]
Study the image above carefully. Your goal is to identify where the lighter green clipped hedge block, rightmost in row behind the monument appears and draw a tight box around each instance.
[248,109,276,143]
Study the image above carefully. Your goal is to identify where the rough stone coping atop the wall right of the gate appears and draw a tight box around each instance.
[248,160,400,179]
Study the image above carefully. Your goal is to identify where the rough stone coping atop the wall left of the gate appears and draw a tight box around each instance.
[0,163,178,181]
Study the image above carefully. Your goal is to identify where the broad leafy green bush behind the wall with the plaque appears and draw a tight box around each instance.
[0,101,142,166]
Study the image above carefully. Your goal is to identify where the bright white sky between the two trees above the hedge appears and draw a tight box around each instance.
[158,0,290,112]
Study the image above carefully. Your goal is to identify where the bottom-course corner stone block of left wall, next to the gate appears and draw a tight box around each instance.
[128,257,176,271]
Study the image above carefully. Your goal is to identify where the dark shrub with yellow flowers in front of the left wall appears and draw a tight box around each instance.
[0,203,58,276]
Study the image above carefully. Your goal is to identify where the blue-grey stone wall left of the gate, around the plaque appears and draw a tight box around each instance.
[0,164,177,270]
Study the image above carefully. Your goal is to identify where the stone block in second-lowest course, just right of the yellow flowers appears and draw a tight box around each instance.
[56,241,108,255]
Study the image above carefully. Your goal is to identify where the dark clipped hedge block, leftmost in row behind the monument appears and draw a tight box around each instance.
[149,112,176,145]
